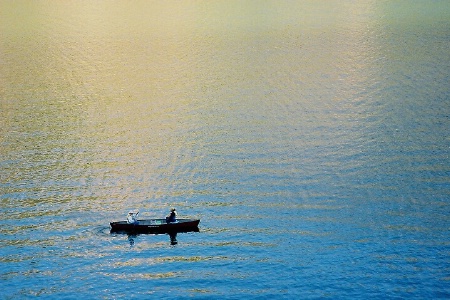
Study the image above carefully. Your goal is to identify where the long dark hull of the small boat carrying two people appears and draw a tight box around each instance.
[110,219,200,233]
